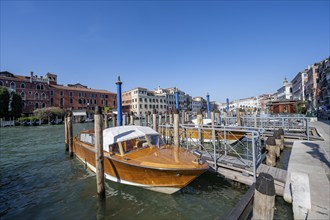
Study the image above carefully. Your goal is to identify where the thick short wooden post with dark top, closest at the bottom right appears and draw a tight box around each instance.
[252,173,275,220]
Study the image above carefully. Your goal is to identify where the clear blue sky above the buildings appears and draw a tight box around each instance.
[0,0,330,102]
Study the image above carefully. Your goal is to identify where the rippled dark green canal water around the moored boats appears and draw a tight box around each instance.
[0,123,293,219]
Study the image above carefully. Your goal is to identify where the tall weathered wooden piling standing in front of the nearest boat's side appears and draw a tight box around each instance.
[94,107,105,199]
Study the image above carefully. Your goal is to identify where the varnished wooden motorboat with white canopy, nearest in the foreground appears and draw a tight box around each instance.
[73,126,209,194]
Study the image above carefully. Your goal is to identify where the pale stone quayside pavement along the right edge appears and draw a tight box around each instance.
[283,120,330,219]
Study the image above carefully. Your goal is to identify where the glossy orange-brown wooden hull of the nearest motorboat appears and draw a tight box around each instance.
[74,139,208,194]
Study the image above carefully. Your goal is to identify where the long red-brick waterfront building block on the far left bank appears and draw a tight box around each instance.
[0,71,116,116]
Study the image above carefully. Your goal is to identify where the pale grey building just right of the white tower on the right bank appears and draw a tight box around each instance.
[291,69,308,101]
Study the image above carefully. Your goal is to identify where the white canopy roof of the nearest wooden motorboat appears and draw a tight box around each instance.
[103,126,159,151]
